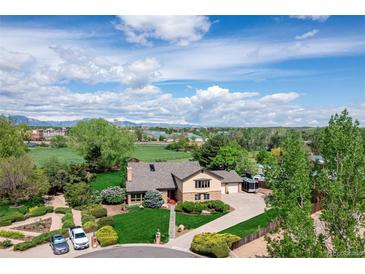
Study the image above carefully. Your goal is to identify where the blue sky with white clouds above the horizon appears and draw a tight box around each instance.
[0,16,365,126]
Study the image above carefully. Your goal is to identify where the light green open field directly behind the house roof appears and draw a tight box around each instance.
[131,145,191,162]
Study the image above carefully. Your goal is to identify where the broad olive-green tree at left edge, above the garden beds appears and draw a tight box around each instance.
[0,155,50,203]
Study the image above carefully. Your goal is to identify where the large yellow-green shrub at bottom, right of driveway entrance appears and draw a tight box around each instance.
[191,233,240,258]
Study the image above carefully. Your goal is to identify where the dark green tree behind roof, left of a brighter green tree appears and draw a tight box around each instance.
[193,135,229,167]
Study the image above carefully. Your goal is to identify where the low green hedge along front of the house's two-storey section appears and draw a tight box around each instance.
[175,200,230,214]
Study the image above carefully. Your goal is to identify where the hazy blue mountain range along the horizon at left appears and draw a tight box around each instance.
[8,115,193,127]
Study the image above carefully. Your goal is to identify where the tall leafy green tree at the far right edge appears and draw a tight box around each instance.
[317,110,365,257]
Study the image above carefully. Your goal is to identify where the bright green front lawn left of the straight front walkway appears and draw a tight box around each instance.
[113,208,170,244]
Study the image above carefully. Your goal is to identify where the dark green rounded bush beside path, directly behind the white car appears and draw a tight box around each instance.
[64,182,91,207]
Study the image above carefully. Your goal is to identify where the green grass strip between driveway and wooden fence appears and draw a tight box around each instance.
[219,212,274,238]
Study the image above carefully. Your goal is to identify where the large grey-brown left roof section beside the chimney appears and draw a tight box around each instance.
[127,162,202,192]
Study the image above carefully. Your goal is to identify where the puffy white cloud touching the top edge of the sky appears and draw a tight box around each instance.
[115,15,211,46]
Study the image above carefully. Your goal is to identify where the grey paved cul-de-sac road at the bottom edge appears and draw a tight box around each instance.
[77,246,198,258]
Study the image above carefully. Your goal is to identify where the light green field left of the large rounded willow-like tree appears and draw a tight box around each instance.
[29,147,84,167]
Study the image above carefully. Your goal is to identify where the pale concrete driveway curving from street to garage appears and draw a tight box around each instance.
[165,192,265,250]
